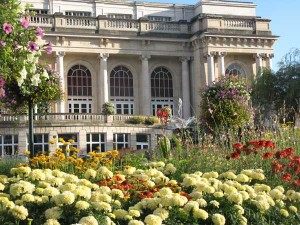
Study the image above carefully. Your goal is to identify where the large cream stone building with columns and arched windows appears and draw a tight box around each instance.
[0,0,278,155]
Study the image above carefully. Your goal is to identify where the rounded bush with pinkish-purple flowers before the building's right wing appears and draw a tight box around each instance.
[201,76,252,129]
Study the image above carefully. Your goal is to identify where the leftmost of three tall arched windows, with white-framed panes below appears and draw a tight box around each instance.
[67,64,92,113]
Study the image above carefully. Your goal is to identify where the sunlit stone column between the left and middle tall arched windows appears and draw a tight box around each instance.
[99,53,109,104]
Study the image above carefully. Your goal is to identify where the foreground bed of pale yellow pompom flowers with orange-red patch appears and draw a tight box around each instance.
[0,162,300,225]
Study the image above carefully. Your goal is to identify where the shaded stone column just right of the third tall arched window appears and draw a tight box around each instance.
[180,57,191,119]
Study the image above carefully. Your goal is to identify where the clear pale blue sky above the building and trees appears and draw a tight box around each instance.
[142,0,300,70]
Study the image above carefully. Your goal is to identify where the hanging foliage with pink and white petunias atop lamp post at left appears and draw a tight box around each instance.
[0,0,62,112]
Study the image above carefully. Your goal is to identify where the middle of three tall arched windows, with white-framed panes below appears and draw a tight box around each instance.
[109,66,134,114]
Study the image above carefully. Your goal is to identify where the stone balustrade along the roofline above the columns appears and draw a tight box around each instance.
[31,13,270,34]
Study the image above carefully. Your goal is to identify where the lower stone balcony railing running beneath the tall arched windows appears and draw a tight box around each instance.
[0,113,150,124]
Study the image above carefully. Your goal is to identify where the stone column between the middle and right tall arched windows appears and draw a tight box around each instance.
[139,55,151,116]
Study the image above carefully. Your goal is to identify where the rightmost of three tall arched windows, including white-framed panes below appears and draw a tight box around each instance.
[151,66,174,115]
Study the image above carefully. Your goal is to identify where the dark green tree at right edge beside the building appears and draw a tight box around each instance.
[252,49,300,122]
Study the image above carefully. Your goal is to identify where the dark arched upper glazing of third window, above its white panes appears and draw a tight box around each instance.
[151,67,173,98]
